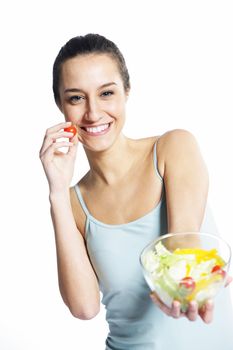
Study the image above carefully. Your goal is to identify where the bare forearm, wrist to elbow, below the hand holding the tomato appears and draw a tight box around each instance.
[49,191,100,320]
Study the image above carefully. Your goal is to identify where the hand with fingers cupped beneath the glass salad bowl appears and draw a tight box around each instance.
[150,276,233,323]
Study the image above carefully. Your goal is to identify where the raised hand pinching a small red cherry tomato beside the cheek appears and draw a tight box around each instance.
[39,122,78,194]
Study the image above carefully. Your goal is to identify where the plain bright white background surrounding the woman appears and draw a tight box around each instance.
[0,0,233,350]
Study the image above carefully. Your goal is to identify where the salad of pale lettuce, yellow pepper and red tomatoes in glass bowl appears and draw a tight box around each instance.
[142,241,226,312]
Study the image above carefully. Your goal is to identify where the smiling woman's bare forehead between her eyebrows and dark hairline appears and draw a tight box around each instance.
[61,54,121,88]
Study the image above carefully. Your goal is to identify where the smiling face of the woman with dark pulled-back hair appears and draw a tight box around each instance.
[59,54,128,151]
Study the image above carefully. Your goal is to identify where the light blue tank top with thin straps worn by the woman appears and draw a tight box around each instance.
[74,143,233,350]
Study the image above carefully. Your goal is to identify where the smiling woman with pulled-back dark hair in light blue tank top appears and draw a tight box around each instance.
[40,34,233,350]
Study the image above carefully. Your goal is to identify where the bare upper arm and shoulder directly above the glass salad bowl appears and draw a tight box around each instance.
[160,129,209,233]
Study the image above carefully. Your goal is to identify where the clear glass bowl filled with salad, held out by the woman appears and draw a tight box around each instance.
[140,232,231,312]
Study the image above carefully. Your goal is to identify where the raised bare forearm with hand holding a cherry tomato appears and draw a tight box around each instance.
[39,122,100,320]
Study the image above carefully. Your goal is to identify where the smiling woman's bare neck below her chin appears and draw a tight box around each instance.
[84,134,135,186]
